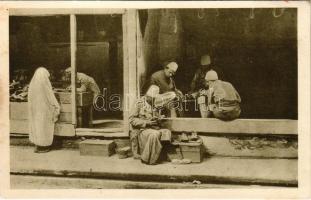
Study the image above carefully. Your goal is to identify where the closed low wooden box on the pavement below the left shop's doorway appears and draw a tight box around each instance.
[79,139,115,157]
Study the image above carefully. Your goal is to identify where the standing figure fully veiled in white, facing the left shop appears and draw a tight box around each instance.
[28,67,60,153]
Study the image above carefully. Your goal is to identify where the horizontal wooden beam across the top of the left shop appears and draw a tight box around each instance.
[9,8,125,16]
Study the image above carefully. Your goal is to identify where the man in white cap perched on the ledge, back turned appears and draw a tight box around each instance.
[199,70,241,120]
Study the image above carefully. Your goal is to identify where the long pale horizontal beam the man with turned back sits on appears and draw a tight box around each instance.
[163,118,298,135]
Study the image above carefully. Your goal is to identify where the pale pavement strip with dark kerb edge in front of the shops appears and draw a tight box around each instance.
[10,146,298,186]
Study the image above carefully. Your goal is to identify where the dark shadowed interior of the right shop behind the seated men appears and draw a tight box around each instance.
[140,8,298,119]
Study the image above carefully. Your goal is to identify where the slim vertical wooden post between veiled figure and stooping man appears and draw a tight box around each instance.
[70,14,77,124]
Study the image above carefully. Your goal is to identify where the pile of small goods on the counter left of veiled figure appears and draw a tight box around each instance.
[10,70,30,102]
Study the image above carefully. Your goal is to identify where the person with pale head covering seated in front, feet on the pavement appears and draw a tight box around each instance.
[129,85,174,164]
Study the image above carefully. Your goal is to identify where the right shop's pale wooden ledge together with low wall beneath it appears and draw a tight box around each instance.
[162,118,298,159]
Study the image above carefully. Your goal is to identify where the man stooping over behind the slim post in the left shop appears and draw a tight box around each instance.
[65,67,100,98]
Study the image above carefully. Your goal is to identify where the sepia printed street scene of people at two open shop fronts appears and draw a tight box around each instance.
[1,2,310,198]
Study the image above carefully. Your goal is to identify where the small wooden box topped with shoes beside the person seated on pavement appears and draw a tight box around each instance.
[168,132,204,164]
